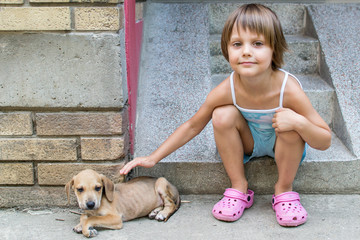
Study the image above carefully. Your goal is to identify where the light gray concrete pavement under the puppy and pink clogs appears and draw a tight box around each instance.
[0,195,360,240]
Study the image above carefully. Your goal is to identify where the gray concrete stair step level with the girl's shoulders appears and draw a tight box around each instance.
[212,73,335,124]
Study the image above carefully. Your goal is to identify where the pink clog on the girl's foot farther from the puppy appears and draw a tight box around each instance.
[272,192,307,227]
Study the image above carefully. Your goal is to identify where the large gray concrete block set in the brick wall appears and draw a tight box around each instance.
[0,33,124,108]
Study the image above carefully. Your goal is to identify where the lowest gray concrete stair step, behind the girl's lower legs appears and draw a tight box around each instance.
[135,134,360,194]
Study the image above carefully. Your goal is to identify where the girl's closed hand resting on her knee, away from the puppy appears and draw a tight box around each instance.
[272,108,302,133]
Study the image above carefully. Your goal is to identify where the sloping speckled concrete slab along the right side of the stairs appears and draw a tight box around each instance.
[308,3,360,157]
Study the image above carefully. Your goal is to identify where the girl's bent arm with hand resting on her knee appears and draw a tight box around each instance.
[273,76,331,150]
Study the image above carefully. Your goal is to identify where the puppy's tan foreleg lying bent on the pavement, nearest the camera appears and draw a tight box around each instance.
[82,215,122,237]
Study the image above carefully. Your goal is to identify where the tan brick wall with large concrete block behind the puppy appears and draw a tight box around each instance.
[0,0,142,207]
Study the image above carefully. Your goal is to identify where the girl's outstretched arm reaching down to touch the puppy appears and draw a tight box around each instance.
[120,81,231,174]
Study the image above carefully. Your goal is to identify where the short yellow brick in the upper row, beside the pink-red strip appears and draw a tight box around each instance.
[75,7,122,31]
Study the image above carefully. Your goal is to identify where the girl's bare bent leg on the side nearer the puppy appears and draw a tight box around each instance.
[212,105,254,193]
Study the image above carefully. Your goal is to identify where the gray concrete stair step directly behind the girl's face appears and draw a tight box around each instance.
[210,35,319,74]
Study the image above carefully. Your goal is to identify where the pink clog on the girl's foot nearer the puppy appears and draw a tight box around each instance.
[212,188,254,222]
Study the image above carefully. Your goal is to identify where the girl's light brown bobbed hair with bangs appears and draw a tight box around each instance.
[221,4,288,70]
